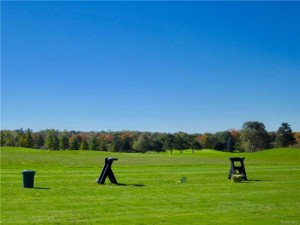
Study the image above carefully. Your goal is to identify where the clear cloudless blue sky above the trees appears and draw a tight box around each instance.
[1,1,300,133]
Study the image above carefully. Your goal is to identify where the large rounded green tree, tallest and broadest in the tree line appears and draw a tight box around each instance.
[241,121,270,152]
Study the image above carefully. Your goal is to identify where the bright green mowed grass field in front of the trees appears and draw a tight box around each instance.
[1,147,300,225]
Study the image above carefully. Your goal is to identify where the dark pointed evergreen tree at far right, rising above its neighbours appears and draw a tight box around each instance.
[275,123,296,147]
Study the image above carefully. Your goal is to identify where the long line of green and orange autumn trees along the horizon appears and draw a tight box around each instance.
[1,121,300,153]
